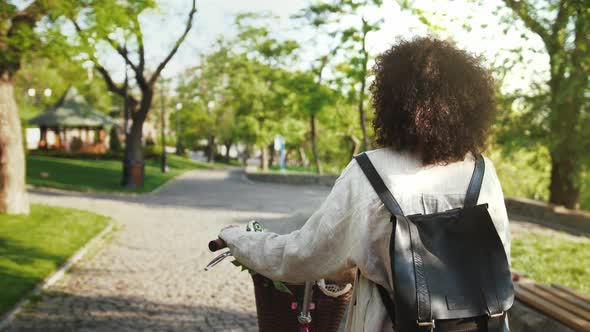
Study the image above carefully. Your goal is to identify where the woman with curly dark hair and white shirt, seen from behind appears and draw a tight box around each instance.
[219,38,510,332]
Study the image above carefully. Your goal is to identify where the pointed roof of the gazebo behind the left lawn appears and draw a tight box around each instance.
[29,87,116,128]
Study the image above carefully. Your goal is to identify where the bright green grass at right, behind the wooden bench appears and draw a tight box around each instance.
[512,232,590,295]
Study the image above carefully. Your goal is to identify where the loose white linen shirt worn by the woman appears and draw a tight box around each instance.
[219,148,510,332]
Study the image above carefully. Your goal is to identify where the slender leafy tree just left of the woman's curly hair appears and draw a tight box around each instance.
[299,0,383,150]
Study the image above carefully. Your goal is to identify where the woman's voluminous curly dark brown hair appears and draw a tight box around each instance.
[370,37,496,165]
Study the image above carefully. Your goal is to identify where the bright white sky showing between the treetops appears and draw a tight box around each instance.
[22,0,548,90]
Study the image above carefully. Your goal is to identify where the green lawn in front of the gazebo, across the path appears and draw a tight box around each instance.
[27,155,211,192]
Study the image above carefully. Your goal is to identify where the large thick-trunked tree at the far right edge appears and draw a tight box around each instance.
[504,0,590,208]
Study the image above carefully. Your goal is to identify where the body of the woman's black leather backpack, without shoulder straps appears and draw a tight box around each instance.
[390,205,514,324]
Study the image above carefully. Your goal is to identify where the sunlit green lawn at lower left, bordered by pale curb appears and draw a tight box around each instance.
[0,205,109,315]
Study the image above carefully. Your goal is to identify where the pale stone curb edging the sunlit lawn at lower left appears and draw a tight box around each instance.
[0,221,115,331]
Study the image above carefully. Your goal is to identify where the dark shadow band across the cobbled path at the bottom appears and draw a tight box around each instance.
[7,292,257,332]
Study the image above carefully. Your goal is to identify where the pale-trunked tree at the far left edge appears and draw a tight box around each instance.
[0,0,49,214]
